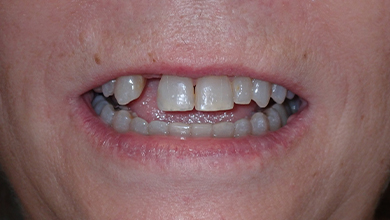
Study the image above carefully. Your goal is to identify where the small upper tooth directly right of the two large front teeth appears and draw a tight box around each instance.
[233,77,252,105]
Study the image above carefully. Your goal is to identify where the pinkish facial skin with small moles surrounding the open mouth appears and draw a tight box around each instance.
[0,0,390,220]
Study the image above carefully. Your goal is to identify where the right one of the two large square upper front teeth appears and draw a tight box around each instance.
[195,76,234,111]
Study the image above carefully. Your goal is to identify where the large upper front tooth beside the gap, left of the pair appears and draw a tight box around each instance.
[157,76,195,111]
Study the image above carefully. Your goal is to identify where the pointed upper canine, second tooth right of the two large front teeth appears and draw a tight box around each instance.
[252,79,271,108]
